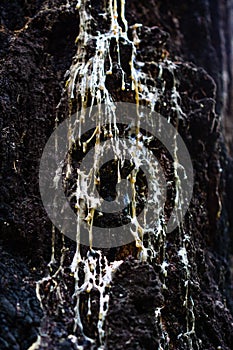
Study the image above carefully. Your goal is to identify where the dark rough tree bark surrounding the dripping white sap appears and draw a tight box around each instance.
[0,0,233,350]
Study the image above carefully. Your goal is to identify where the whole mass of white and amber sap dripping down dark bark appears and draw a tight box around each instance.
[34,0,198,350]
